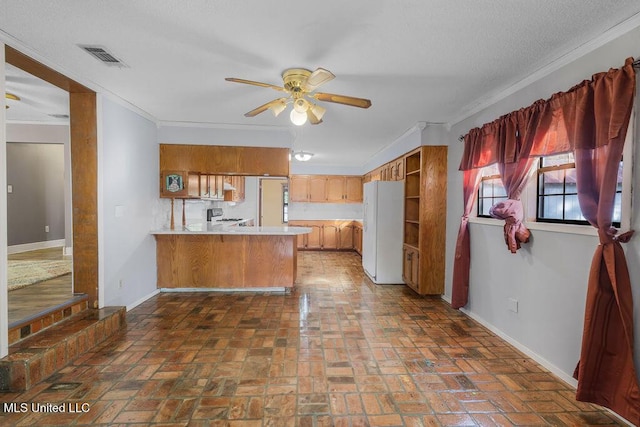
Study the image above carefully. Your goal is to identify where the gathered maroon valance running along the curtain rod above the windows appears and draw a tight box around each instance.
[459,58,635,171]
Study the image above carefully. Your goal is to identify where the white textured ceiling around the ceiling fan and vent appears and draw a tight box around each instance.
[0,0,640,165]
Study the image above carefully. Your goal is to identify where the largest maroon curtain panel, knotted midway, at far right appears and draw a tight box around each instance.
[552,59,640,425]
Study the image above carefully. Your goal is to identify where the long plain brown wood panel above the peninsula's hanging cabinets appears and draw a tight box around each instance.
[160,144,289,177]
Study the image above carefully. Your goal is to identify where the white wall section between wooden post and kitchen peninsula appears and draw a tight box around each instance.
[98,97,160,307]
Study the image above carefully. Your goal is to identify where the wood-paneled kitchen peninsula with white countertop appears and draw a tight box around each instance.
[152,223,311,291]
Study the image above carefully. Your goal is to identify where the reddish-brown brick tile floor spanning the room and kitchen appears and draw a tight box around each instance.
[0,252,621,427]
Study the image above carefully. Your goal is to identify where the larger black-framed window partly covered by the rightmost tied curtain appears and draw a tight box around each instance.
[536,153,622,227]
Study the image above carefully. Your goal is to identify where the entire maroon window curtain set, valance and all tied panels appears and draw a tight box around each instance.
[452,58,640,425]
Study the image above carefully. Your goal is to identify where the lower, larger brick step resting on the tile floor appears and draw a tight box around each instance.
[0,307,126,392]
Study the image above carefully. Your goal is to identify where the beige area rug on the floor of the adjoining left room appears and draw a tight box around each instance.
[8,260,71,291]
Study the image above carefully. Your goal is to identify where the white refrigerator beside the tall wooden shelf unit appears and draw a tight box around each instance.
[362,181,404,284]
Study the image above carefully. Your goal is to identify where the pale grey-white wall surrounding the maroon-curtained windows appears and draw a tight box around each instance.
[445,23,640,383]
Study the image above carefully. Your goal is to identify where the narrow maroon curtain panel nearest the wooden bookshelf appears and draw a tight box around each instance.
[451,169,480,308]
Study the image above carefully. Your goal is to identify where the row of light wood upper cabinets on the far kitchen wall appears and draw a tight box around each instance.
[289,175,362,203]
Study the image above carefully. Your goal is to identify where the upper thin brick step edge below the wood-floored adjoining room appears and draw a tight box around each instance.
[9,294,89,345]
